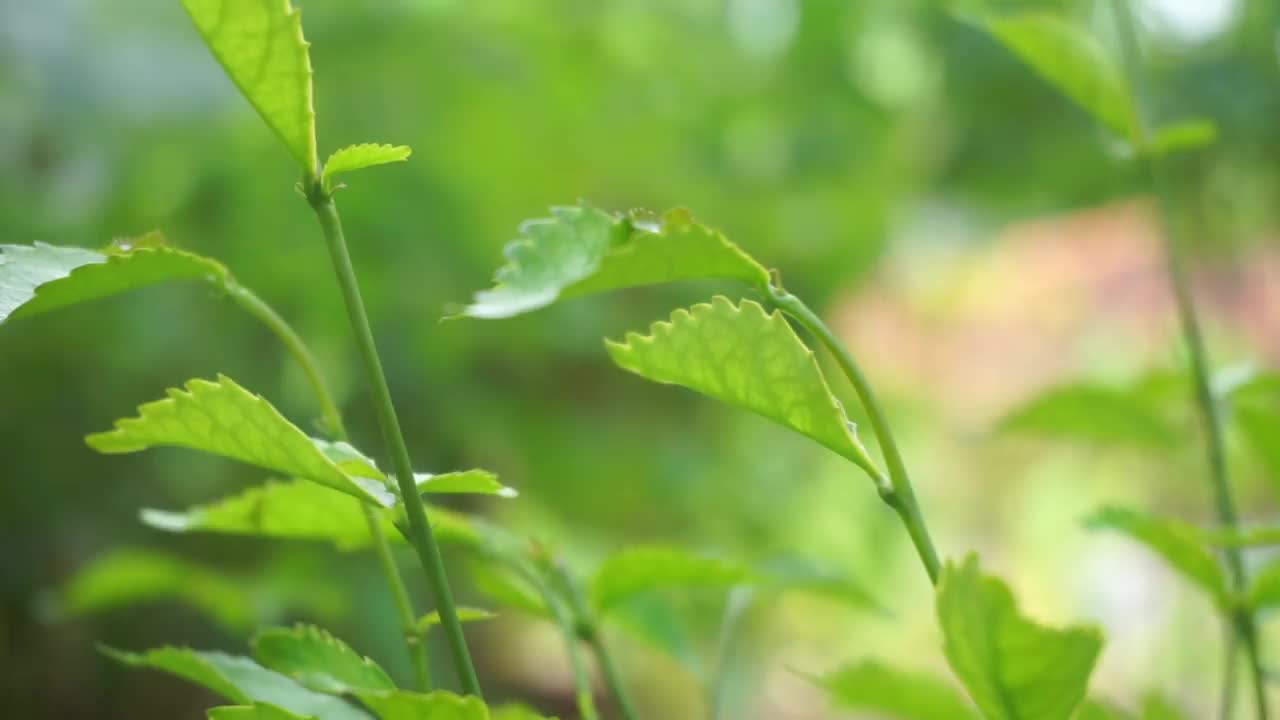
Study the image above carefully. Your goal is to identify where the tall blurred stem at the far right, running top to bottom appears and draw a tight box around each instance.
[1112,0,1267,720]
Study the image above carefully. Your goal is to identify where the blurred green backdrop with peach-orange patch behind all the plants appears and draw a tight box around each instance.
[0,0,1280,719]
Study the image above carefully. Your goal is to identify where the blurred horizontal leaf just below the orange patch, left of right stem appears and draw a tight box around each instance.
[1000,384,1181,448]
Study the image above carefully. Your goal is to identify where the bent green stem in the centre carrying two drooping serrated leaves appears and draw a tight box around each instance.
[767,286,942,584]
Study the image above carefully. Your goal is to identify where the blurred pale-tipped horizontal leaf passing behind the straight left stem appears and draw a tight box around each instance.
[141,480,480,551]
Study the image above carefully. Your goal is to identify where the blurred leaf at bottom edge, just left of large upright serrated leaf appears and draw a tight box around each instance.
[818,660,978,720]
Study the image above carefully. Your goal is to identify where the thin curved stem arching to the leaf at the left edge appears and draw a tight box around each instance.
[223,278,431,692]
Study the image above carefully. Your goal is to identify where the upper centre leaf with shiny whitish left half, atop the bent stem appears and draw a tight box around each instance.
[462,205,769,318]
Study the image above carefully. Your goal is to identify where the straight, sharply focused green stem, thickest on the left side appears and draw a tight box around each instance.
[307,183,483,697]
